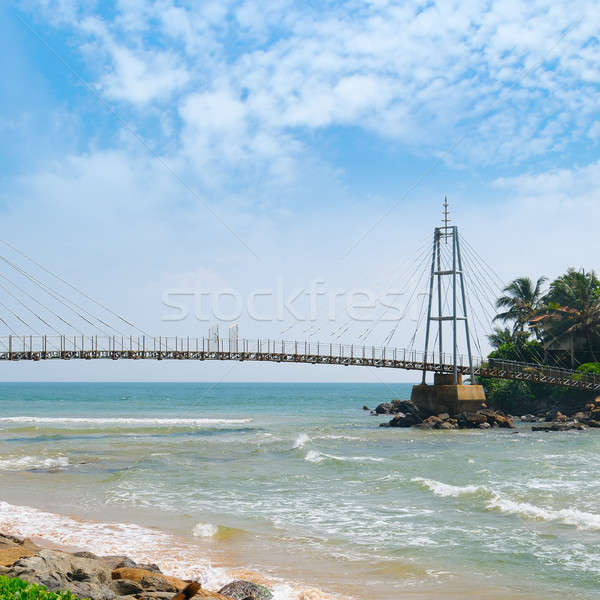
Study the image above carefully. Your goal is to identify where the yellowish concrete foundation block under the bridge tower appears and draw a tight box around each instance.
[410,373,485,415]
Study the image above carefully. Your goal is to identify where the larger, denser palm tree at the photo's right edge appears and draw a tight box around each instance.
[544,269,600,363]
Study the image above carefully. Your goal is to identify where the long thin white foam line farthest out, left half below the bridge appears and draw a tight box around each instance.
[0,416,252,427]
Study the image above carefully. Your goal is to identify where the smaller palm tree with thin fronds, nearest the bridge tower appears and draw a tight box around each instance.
[494,277,546,336]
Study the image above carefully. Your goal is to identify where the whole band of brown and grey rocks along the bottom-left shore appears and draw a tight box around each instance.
[0,534,272,600]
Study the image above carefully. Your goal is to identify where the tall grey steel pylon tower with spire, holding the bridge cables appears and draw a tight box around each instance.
[423,197,475,384]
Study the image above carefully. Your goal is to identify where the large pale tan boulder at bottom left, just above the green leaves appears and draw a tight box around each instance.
[6,550,116,600]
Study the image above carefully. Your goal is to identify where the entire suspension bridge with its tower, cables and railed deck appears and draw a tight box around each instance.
[0,202,600,392]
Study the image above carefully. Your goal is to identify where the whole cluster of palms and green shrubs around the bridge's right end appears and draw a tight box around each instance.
[482,269,600,413]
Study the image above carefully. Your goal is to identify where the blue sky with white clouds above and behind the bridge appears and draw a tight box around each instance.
[0,0,600,382]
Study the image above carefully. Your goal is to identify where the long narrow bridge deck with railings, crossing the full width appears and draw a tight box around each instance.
[0,336,600,391]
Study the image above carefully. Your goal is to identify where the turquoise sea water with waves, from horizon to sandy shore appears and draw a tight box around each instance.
[0,383,600,599]
